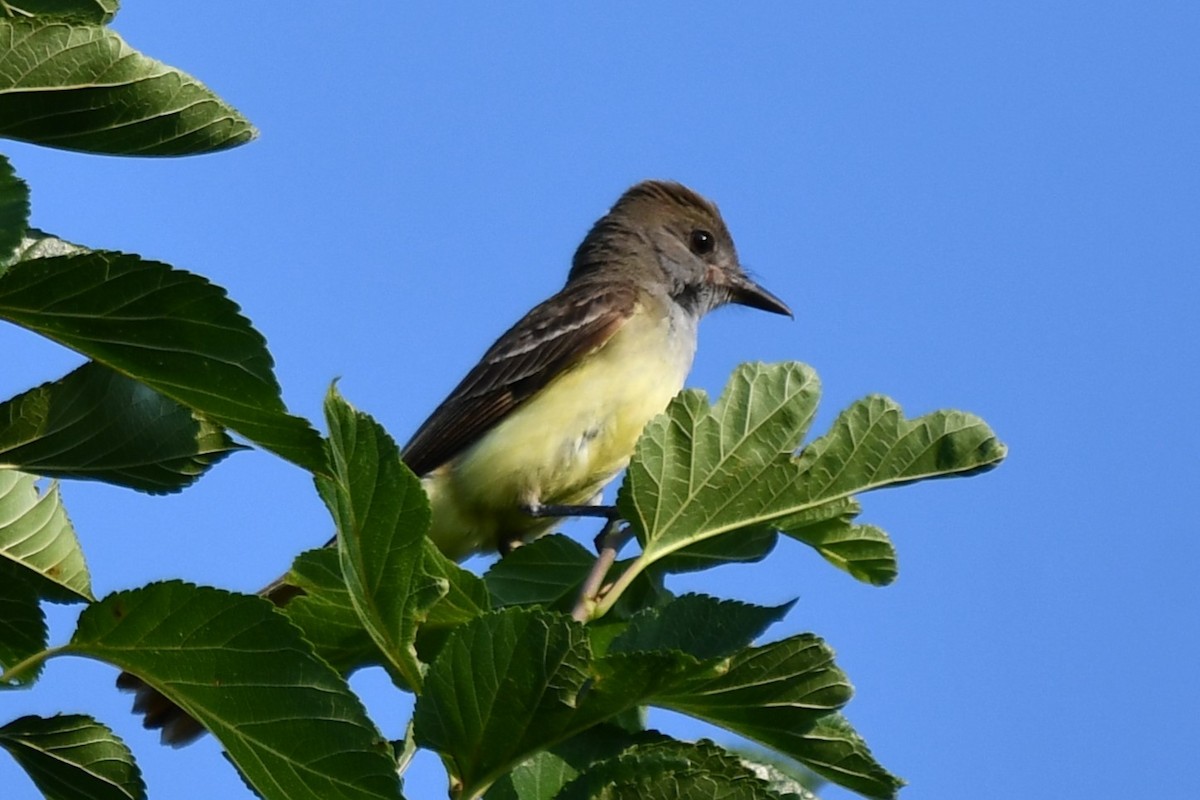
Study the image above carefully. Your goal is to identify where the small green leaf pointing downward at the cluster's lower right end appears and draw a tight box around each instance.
[796,714,905,798]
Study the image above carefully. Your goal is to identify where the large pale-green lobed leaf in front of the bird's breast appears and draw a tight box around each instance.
[609,363,1007,606]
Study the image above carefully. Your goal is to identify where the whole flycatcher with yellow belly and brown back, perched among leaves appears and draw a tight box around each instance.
[118,180,792,746]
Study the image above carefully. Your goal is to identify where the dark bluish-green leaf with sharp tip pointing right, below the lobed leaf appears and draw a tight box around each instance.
[608,595,794,660]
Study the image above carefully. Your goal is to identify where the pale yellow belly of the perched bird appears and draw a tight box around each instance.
[422,297,696,558]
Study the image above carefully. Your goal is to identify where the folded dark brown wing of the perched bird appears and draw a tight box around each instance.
[402,281,637,475]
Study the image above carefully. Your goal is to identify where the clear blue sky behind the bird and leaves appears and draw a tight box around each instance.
[0,6,1200,800]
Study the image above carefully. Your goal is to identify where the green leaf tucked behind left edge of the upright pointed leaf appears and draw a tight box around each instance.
[282,547,383,675]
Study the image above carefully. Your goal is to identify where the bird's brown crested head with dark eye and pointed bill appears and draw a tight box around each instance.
[568,181,792,315]
